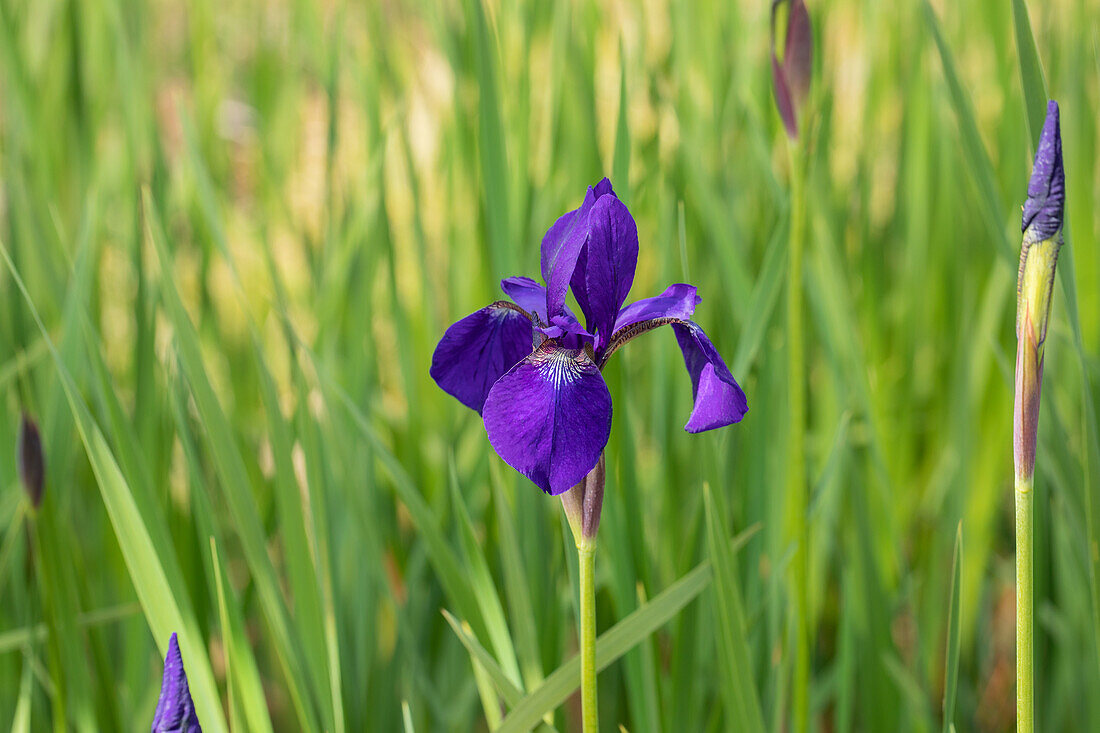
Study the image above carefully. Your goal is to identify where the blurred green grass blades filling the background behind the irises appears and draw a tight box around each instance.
[0,0,1100,732]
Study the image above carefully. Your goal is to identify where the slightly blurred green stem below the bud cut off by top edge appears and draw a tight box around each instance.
[787,141,810,731]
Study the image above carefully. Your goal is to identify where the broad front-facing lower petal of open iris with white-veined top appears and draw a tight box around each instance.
[483,341,612,495]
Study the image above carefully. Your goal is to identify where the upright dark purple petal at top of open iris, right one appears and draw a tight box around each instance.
[573,195,638,340]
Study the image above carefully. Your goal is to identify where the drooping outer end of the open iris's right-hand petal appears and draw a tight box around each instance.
[672,321,749,433]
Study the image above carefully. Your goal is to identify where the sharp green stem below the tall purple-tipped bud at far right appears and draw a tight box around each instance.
[1016,479,1035,733]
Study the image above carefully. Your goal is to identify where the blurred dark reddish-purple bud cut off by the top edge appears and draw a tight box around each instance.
[771,0,814,140]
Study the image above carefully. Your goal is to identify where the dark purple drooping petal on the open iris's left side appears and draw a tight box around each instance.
[429,304,534,413]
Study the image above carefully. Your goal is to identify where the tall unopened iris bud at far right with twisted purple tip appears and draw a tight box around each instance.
[1013,100,1066,485]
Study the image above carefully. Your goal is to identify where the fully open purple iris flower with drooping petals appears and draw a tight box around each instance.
[431,178,748,495]
